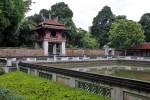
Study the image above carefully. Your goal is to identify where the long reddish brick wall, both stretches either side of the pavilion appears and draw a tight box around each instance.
[0,47,121,57]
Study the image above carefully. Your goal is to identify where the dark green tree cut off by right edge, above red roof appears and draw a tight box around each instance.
[139,13,150,42]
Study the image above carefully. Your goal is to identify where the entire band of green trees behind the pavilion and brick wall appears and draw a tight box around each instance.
[0,0,150,48]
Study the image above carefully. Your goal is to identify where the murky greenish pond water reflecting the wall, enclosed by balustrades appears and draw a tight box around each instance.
[65,65,150,81]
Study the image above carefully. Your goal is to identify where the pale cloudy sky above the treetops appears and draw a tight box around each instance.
[27,0,150,30]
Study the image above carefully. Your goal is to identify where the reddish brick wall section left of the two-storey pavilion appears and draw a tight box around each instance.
[0,48,44,57]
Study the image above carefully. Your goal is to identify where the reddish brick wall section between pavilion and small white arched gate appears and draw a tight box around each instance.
[66,48,104,56]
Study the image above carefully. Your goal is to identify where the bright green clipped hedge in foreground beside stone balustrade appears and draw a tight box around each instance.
[0,71,110,100]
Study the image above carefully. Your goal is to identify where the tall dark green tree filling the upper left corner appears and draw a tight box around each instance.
[0,0,25,46]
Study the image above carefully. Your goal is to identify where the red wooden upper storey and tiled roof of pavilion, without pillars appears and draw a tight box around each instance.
[34,19,68,43]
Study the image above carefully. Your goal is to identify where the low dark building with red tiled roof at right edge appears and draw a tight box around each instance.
[127,42,150,56]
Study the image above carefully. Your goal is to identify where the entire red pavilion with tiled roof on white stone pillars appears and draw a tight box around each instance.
[33,19,68,56]
